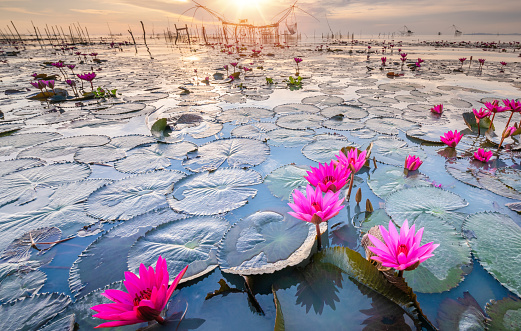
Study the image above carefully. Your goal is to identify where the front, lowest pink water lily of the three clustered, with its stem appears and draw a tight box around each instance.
[288,184,344,250]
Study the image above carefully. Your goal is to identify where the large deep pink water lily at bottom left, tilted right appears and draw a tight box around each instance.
[91,256,188,328]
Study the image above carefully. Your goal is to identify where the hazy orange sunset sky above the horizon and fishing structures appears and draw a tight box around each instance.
[0,0,521,35]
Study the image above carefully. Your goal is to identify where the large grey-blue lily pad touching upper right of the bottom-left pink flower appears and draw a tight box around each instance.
[128,216,229,282]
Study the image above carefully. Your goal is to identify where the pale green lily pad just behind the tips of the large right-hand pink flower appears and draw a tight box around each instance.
[385,186,468,224]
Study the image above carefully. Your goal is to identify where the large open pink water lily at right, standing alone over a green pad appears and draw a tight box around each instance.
[367,220,439,271]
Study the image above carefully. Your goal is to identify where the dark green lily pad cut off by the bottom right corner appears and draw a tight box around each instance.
[486,297,521,330]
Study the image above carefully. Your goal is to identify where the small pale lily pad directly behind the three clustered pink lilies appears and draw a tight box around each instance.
[302,136,358,163]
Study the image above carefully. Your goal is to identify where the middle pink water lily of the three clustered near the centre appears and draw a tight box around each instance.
[304,161,351,193]
